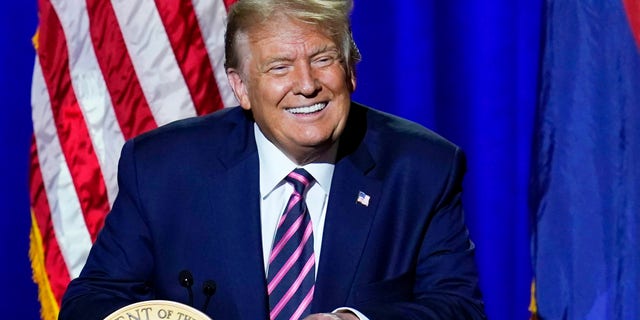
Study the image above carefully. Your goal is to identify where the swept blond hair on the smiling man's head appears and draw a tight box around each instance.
[224,0,360,77]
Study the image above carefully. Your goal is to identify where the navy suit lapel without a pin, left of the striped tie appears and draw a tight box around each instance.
[205,111,268,319]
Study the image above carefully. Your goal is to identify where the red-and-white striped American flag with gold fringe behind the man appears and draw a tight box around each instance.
[29,0,236,319]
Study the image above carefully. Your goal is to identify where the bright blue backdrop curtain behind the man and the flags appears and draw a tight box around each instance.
[0,0,541,320]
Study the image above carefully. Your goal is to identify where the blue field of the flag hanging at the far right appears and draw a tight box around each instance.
[530,0,640,320]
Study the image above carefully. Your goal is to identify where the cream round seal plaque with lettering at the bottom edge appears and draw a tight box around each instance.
[104,300,213,320]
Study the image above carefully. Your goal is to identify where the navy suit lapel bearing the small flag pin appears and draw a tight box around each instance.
[312,107,382,312]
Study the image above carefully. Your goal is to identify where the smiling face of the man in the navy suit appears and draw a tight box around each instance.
[227,15,355,164]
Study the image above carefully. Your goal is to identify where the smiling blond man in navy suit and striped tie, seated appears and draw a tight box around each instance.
[60,0,484,320]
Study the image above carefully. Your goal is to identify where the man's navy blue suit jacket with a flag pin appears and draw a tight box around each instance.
[60,103,484,320]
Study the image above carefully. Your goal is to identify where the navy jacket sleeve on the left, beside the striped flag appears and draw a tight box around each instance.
[58,141,153,320]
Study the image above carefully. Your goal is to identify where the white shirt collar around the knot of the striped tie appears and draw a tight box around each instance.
[253,123,335,199]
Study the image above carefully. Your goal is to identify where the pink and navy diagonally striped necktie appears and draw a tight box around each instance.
[267,168,316,320]
